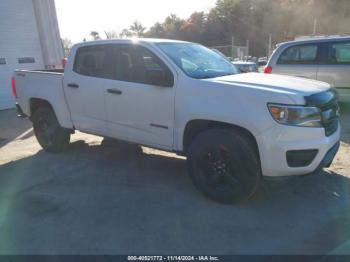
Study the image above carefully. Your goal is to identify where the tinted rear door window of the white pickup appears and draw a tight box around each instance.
[73,45,113,79]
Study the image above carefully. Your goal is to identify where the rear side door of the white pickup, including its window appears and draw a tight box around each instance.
[64,45,113,135]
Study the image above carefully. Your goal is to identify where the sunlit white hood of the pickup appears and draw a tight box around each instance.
[206,73,331,96]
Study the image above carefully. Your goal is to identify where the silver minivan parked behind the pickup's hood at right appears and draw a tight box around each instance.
[265,37,350,101]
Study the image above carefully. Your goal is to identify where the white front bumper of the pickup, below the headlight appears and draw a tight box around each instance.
[257,124,341,177]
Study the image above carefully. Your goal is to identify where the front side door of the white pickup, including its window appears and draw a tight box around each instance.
[105,44,175,149]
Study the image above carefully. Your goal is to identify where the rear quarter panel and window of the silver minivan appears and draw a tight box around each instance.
[273,44,318,79]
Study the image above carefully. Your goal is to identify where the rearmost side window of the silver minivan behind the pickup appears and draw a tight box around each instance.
[277,44,318,64]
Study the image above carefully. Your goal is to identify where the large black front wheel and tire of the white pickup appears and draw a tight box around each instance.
[187,128,261,204]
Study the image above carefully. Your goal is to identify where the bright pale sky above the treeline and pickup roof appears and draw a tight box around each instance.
[55,0,216,43]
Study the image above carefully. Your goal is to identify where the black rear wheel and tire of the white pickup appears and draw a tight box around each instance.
[32,107,70,153]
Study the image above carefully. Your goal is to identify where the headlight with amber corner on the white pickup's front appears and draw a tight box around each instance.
[268,104,322,127]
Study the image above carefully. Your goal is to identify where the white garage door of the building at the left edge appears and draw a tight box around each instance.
[0,0,44,110]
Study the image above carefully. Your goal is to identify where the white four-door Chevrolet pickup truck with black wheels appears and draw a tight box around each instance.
[12,39,340,203]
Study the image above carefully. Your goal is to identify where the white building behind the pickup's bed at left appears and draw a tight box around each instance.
[0,0,64,110]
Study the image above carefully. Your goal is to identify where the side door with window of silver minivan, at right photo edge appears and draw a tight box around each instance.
[317,41,350,89]
